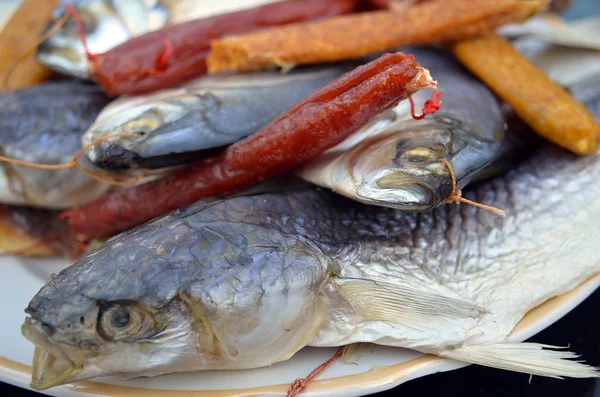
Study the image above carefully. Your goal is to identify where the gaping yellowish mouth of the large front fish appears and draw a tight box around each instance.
[21,318,80,390]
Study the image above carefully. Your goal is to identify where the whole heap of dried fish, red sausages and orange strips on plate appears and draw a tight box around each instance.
[0,0,600,389]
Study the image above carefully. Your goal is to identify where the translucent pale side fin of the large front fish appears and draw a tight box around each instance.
[335,278,486,326]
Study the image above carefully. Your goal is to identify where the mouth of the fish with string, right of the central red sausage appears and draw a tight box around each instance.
[356,172,439,211]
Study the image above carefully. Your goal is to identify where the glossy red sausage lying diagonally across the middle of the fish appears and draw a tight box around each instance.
[68,53,434,238]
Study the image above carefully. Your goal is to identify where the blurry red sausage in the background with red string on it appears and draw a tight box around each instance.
[89,0,358,95]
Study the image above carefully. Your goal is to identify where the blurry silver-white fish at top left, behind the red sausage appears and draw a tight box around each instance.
[37,0,170,79]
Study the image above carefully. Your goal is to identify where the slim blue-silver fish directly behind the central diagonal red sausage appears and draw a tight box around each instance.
[83,63,356,171]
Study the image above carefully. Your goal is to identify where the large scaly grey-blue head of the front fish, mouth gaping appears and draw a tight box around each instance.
[22,194,333,389]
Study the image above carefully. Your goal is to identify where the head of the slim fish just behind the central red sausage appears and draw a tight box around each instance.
[82,98,195,172]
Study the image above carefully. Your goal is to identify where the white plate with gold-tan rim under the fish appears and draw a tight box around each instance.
[0,257,600,397]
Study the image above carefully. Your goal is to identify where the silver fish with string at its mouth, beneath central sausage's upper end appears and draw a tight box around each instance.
[297,48,505,211]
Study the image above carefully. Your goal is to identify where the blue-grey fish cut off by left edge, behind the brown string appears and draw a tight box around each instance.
[0,81,110,208]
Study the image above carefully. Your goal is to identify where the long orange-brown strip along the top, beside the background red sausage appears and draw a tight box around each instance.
[207,0,549,73]
